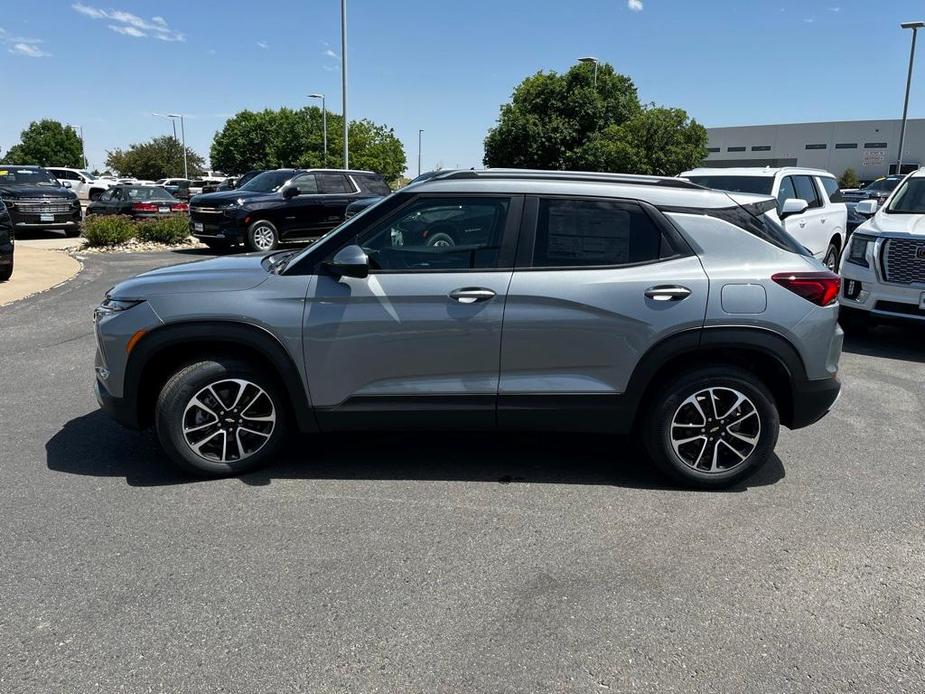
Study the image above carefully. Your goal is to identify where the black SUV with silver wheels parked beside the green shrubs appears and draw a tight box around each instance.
[190,169,390,251]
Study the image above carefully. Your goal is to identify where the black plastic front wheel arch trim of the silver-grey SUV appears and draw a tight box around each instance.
[123,321,317,431]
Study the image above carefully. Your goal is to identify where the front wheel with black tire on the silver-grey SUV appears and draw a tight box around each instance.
[154,358,288,477]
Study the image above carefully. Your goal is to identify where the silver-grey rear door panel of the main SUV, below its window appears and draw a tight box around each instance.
[499,256,708,400]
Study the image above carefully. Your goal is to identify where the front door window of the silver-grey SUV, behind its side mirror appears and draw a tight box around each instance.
[358,197,510,272]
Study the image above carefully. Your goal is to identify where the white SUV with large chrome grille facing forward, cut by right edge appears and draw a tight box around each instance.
[839,168,925,329]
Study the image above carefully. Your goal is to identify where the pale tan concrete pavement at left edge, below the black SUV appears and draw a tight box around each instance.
[0,245,81,306]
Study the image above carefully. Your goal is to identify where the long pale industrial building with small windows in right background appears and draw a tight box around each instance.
[704,118,925,181]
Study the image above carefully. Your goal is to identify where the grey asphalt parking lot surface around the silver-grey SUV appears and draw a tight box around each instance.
[0,252,925,693]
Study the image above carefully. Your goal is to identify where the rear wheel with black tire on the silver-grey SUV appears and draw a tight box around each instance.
[643,366,780,489]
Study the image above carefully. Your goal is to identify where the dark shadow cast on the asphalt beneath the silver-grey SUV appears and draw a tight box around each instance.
[45,411,785,492]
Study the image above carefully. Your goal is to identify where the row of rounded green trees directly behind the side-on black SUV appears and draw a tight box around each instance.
[210,106,406,180]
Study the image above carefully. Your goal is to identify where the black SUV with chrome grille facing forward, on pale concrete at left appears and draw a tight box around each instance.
[0,164,81,236]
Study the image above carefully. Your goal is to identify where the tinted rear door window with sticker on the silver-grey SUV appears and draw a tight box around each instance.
[533,199,662,267]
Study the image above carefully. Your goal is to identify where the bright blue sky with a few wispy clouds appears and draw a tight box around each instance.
[0,0,925,173]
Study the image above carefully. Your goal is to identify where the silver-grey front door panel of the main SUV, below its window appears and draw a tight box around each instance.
[304,271,511,427]
